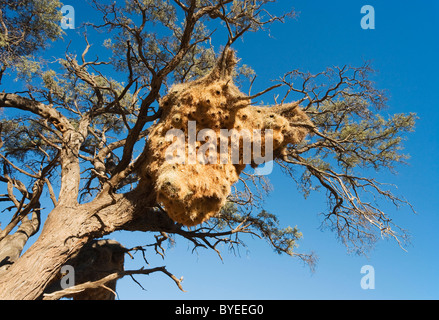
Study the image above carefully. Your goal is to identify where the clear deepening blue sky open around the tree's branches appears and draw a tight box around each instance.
[3,0,439,299]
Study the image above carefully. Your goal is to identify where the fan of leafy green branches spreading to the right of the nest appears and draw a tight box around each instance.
[279,64,417,253]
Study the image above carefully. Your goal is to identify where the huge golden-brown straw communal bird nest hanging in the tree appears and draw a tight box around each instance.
[141,50,312,226]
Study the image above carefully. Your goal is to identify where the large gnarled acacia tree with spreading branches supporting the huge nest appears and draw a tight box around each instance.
[0,0,416,299]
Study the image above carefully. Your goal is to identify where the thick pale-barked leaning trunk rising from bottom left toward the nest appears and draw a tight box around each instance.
[0,184,174,300]
